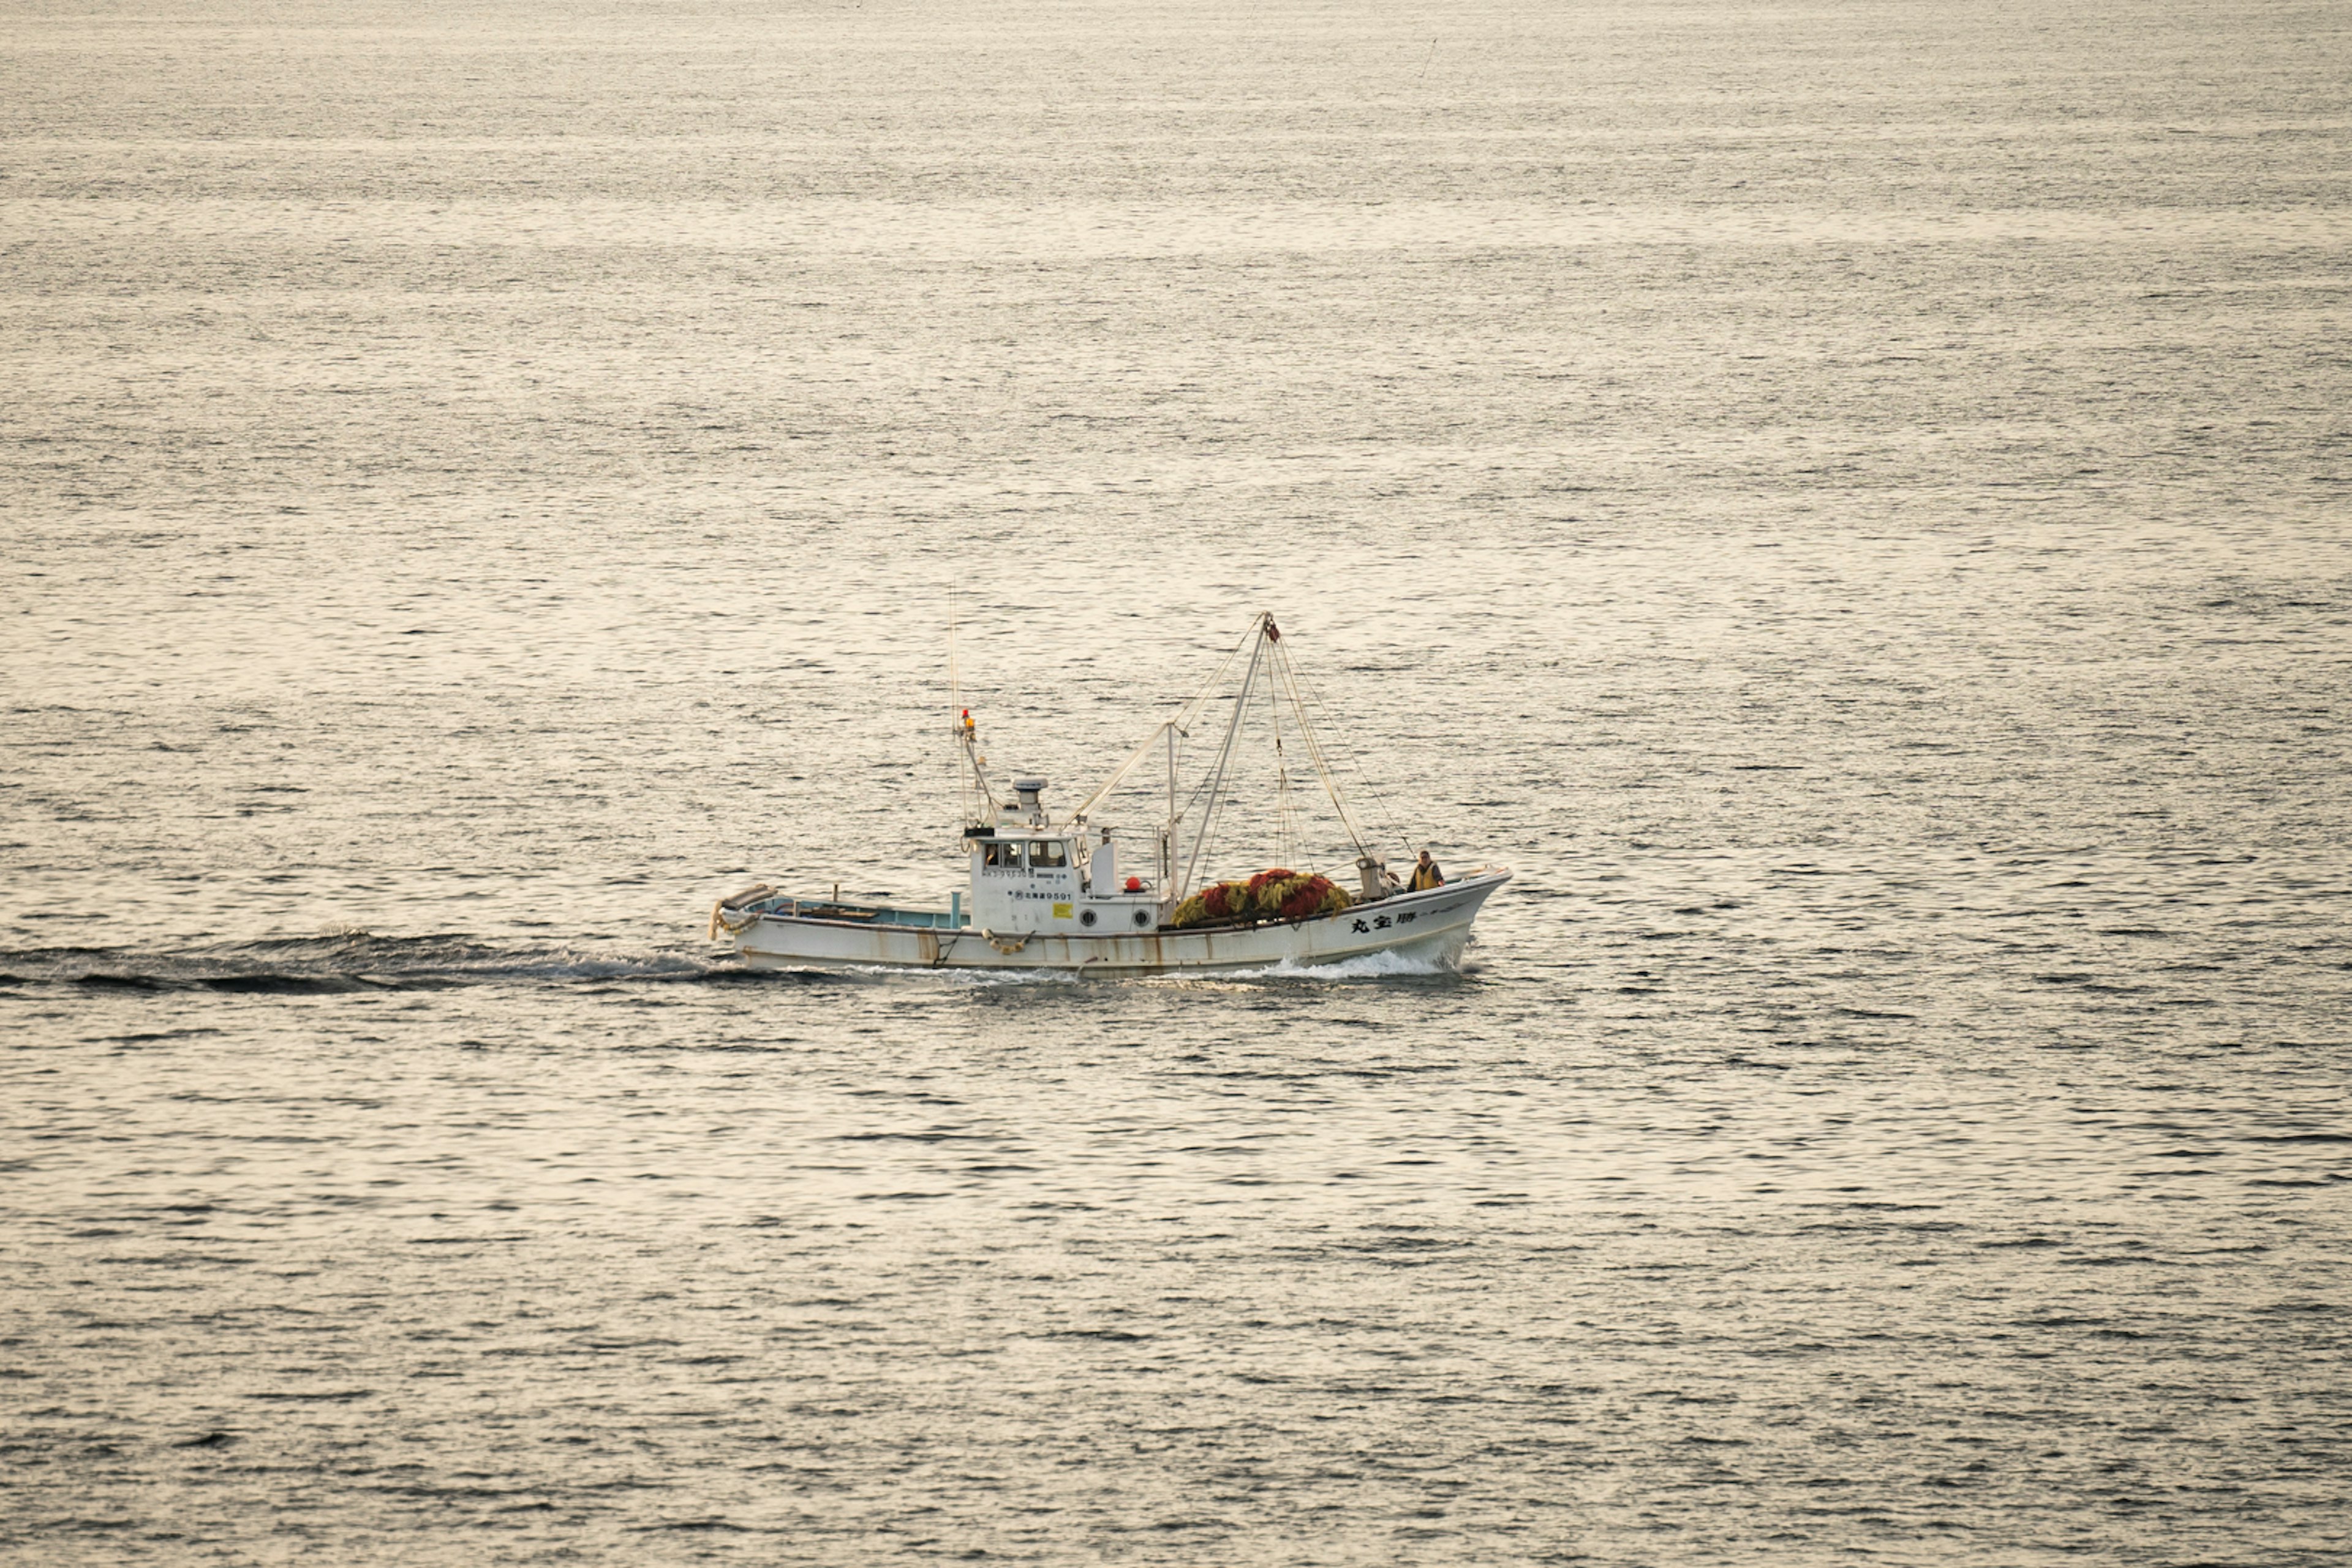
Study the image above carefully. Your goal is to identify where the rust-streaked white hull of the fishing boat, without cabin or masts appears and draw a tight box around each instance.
[734,870,1510,976]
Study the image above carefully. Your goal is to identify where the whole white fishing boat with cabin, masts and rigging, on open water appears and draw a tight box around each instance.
[710,614,1510,976]
